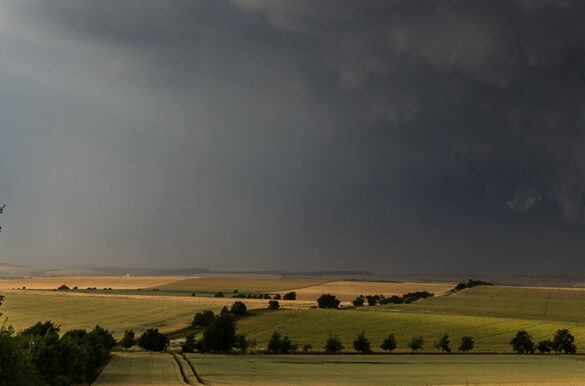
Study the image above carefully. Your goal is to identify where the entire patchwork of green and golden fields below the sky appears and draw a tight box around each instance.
[0,277,585,384]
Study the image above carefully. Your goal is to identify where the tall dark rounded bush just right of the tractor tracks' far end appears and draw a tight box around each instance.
[197,309,236,353]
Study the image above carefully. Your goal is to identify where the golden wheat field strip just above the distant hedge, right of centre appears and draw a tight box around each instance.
[282,281,455,302]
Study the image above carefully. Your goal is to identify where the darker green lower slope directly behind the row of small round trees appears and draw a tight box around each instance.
[238,307,585,352]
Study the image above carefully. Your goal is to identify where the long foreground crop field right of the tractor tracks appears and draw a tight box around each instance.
[187,354,585,385]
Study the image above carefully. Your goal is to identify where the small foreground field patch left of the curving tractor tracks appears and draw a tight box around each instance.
[94,352,185,385]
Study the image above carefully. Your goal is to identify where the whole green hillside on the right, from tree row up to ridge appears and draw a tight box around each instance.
[238,286,585,352]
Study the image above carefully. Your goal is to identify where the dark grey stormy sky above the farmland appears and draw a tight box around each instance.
[0,0,585,274]
